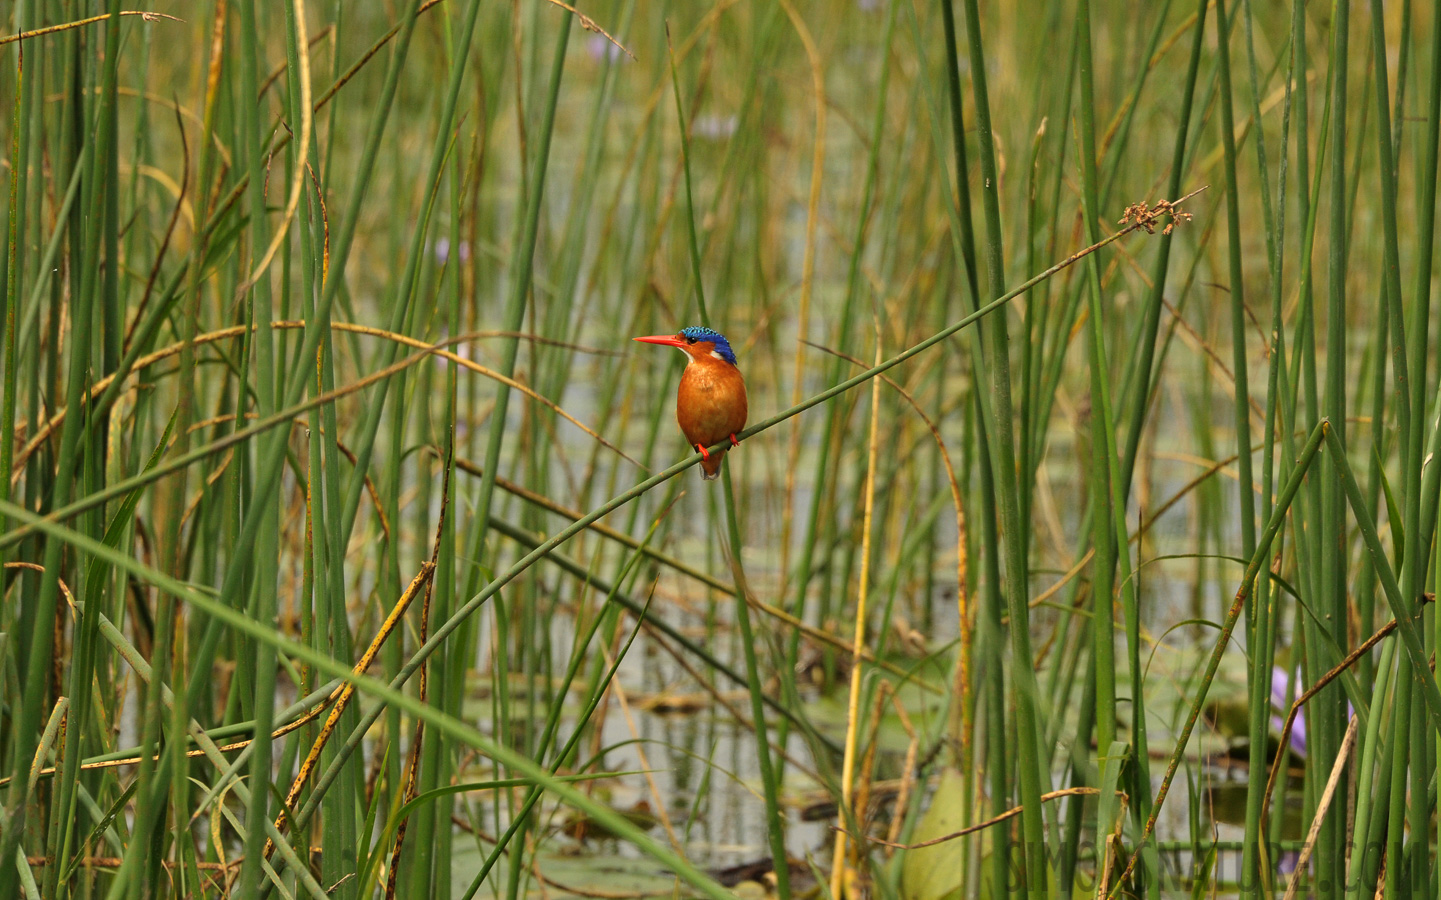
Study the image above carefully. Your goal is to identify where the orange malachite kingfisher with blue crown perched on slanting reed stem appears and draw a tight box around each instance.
[635,325,746,481]
